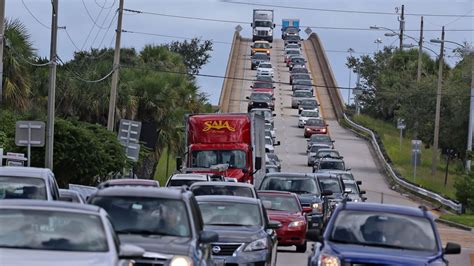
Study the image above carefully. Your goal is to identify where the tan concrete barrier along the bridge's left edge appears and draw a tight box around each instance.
[219,31,241,113]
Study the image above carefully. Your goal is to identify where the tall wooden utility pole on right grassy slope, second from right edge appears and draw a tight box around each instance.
[431,26,444,176]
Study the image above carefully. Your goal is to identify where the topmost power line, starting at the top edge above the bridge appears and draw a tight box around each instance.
[222,0,474,18]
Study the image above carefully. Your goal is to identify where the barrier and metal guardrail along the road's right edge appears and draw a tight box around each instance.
[308,33,463,213]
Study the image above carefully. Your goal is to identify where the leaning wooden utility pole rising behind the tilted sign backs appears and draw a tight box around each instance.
[107,0,124,131]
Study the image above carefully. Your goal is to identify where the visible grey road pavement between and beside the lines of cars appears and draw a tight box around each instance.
[224,36,474,266]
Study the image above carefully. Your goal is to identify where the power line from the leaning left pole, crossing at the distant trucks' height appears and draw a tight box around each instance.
[124,8,474,32]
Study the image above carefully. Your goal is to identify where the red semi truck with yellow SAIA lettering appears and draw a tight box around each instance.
[185,113,265,184]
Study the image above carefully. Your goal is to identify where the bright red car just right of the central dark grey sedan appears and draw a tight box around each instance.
[258,191,308,253]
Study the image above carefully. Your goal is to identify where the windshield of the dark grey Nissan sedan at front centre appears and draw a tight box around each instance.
[198,201,263,226]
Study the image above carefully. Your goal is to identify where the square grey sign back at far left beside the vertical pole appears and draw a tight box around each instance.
[15,121,45,147]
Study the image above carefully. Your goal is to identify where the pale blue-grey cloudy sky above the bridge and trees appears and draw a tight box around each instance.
[6,0,474,104]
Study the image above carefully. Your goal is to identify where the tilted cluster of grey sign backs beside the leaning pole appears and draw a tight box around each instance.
[118,119,142,162]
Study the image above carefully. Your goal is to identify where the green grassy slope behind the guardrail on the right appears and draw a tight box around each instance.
[354,115,462,199]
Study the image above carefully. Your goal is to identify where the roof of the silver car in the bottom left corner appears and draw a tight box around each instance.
[0,199,100,214]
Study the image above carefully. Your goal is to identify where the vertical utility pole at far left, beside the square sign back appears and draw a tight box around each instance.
[45,0,59,171]
